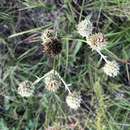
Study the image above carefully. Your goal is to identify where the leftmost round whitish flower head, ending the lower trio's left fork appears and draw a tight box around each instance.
[18,81,34,97]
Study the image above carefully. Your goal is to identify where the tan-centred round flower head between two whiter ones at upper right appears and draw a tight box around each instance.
[86,33,107,51]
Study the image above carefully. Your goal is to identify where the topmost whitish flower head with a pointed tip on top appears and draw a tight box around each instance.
[77,16,93,37]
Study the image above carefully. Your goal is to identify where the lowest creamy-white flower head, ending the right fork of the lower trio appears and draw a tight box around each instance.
[66,92,81,110]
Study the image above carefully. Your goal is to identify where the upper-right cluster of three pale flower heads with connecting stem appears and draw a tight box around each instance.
[77,18,120,77]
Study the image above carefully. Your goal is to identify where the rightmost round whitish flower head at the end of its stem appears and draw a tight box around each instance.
[103,61,120,77]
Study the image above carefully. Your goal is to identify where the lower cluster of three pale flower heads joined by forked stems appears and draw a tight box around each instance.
[18,70,81,110]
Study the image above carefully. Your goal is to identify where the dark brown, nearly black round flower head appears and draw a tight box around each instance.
[43,38,62,56]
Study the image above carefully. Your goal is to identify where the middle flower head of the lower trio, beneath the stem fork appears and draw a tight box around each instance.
[44,71,61,92]
